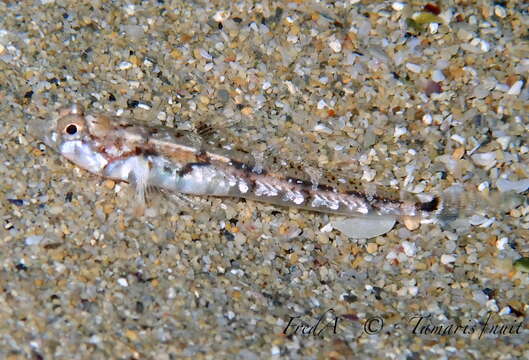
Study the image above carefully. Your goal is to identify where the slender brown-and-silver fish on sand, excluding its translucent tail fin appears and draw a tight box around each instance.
[30,105,443,218]
